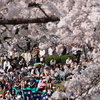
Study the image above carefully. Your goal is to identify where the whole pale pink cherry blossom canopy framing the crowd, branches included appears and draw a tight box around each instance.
[0,0,100,100]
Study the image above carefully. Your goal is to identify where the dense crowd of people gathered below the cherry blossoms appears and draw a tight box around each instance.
[0,45,96,100]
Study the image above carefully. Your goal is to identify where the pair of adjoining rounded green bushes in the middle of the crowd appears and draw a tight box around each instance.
[45,55,75,65]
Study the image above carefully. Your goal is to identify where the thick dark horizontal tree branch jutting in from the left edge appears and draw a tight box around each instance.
[0,16,60,25]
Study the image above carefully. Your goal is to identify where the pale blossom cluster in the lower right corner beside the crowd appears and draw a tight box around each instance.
[62,62,100,100]
